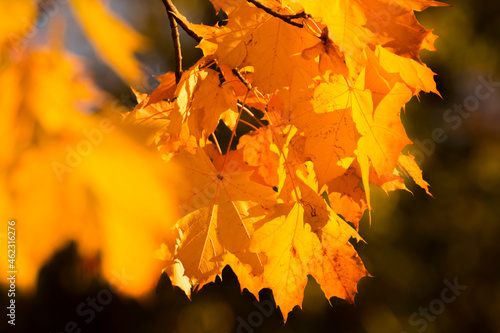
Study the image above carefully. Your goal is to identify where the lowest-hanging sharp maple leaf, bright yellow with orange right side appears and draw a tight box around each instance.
[250,162,368,320]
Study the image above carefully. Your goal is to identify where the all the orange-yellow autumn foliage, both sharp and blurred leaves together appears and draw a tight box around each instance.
[0,0,444,318]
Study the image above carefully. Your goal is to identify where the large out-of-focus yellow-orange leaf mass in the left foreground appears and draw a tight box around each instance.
[0,37,176,295]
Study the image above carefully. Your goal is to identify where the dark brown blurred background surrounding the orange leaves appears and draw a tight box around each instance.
[0,0,500,333]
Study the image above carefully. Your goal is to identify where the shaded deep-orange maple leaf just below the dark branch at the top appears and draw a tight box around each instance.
[194,2,317,93]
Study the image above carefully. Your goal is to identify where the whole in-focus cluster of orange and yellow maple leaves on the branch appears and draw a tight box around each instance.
[147,0,442,318]
